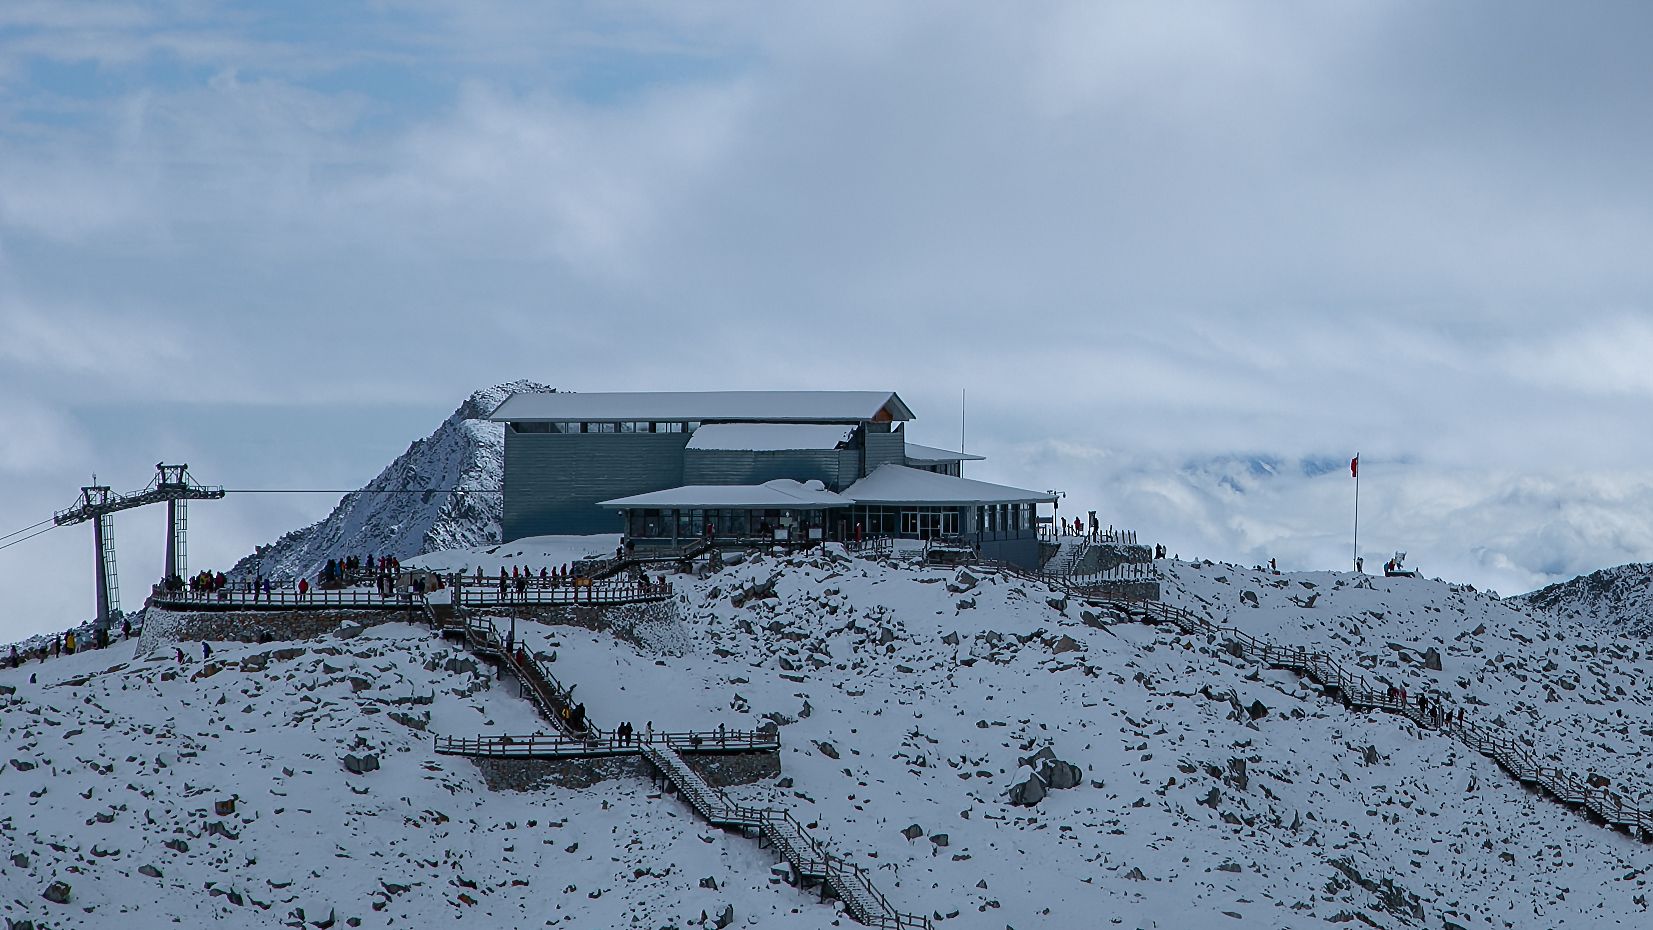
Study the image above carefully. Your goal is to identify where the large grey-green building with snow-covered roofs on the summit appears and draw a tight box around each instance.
[491,391,1053,565]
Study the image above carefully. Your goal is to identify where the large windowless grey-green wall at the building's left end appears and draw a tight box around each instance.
[503,426,689,540]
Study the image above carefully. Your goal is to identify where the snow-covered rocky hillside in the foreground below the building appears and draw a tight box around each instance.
[0,543,1653,930]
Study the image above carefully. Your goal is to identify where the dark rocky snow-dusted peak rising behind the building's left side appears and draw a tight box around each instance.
[231,382,555,581]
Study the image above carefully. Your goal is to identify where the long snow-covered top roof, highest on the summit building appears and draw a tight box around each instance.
[489,391,912,423]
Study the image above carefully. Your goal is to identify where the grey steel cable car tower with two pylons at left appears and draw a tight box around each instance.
[51,464,223,629]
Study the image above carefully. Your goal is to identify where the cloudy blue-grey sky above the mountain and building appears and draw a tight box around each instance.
[0,0,1653,638]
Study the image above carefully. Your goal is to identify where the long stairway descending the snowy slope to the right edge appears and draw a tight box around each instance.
[993,565,1653,841]
